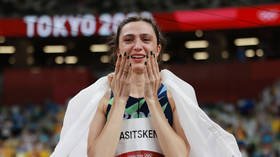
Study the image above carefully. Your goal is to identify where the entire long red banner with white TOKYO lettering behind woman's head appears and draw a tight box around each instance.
[0,3,280,38]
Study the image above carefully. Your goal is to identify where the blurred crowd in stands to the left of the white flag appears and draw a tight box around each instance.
[0,101,65,157]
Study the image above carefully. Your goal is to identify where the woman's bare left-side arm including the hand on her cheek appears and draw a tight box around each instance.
[88,52,131,157]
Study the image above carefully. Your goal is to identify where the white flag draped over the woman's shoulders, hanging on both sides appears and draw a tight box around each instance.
[51,70,241,157]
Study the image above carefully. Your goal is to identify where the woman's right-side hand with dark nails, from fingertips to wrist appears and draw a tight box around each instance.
[144,51,161,101]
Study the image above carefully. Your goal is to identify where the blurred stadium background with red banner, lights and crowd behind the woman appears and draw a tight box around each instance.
[0,0,280,157]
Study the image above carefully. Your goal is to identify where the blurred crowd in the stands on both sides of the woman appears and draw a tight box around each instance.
[0,79,280,157]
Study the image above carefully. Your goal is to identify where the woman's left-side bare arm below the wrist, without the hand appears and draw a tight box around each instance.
[88,91,125,157]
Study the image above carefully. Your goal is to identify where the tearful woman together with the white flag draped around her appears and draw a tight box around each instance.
[51,17,241,157]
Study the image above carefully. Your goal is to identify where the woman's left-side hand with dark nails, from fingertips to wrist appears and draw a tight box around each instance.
[109,52,132,102]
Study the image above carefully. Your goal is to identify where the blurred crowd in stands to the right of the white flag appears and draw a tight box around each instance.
[203,82,280,157]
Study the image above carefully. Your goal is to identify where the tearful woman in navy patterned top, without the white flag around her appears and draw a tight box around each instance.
[88,17,190,157]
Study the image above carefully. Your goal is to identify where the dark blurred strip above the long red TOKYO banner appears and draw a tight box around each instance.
[0,0,278,17]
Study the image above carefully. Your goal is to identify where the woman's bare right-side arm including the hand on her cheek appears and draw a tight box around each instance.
[145,52,190,157]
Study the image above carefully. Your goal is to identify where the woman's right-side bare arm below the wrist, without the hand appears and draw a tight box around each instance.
[144,91,190,157]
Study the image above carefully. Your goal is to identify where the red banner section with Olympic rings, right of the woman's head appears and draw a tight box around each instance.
[160,4,280,32]
